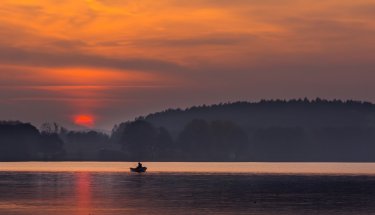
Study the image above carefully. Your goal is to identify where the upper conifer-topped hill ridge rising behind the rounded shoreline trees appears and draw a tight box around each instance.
[144,99,375,133]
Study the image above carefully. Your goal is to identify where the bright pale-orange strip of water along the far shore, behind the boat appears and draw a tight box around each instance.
[0,162,375,175]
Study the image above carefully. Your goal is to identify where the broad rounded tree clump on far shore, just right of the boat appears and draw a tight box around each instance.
[177,119,248,161]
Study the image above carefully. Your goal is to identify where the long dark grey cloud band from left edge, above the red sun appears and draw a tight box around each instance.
[0,46,187,73]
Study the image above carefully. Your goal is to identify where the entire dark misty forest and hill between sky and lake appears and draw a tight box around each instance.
[0,98,375,162]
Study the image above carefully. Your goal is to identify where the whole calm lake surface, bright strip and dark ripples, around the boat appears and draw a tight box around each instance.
[0,162,375,215]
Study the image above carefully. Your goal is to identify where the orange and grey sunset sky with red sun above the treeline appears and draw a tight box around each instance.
[0,0,375,130]
